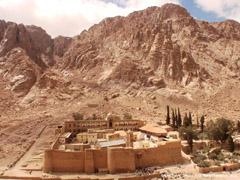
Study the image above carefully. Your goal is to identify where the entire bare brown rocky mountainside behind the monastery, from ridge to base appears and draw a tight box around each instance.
[0,4,240,168]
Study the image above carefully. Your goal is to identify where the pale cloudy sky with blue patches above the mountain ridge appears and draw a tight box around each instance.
[0,0,240,37]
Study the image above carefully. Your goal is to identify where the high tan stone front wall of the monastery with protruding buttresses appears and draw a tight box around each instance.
[43,141,183,174]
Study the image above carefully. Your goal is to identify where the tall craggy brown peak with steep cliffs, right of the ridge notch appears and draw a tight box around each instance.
[58,4,240,87]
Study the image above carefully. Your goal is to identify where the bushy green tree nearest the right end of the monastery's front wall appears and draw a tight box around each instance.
[178,126,197,152]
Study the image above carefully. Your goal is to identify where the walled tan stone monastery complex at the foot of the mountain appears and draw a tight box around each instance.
[43,115,183,174]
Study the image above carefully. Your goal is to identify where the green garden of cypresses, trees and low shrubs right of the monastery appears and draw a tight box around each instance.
[166,106,240,167]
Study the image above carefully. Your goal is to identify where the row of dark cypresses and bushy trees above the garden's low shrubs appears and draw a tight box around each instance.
[166,106,236,152]
